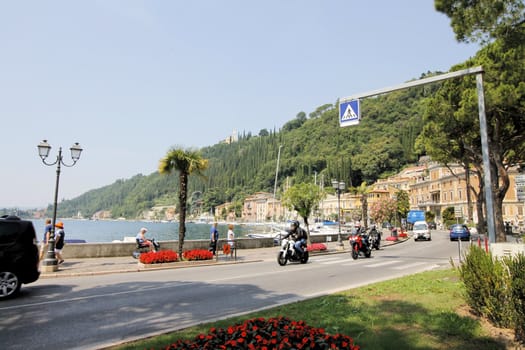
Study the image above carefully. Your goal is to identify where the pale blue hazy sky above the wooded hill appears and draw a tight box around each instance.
[0,0,478,207]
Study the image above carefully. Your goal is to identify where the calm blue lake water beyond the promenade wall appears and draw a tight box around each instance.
[32,219,270,243]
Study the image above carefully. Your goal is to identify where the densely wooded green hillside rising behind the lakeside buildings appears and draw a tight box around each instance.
[49,73,436,219]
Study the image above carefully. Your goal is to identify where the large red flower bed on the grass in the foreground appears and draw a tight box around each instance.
[165,317,359,350]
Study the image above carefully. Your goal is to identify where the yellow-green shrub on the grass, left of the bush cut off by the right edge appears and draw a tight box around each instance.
[459,245,513,328]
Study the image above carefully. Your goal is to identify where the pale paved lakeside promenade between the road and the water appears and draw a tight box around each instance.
[40,238,408,279]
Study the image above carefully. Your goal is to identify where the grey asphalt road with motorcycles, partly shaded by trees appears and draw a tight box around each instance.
[0,231,466,349]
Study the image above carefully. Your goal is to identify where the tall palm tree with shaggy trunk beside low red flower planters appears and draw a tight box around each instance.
[159,148,208,257]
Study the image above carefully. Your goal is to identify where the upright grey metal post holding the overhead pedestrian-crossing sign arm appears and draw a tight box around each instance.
[476,72,496,243]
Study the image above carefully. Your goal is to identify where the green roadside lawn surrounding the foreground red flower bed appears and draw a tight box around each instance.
[114,269,505,350]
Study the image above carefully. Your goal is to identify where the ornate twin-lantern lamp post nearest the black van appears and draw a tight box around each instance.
[38,140,82,272]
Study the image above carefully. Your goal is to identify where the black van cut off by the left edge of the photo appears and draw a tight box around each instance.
[0,215,40,300]
